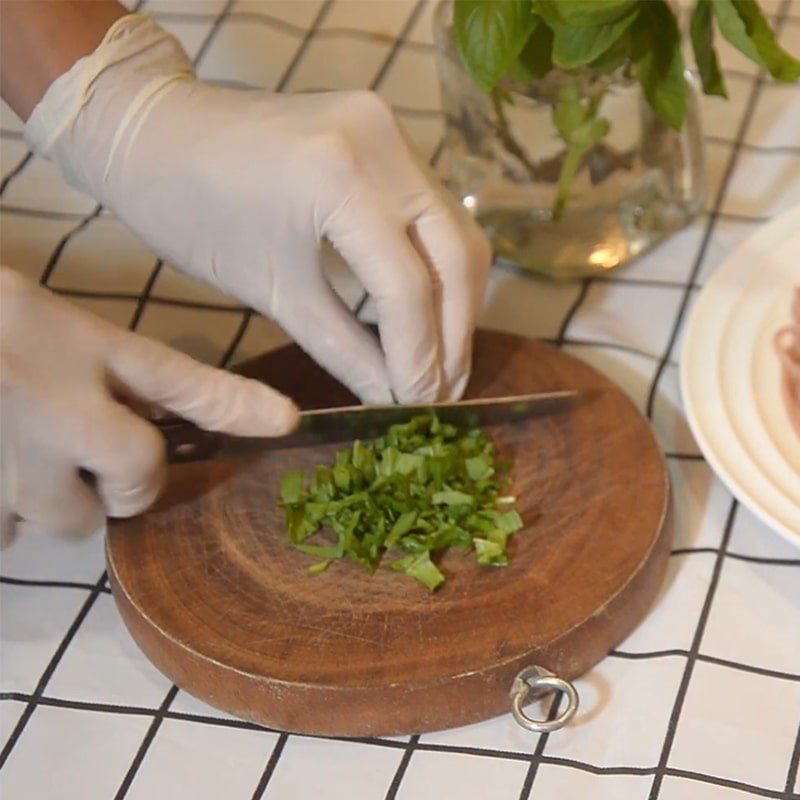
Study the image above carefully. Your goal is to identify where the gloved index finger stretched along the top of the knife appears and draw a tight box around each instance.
[108,334,299,436]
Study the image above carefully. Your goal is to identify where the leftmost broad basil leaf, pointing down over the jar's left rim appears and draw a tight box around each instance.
[456,0,534,90]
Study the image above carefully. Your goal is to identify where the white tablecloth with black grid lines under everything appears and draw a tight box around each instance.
[0,0,800,800]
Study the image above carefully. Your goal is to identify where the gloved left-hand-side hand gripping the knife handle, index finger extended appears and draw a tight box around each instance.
[0,268,298,545]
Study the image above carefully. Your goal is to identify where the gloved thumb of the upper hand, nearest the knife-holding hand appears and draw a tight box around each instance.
[273,268,393,405]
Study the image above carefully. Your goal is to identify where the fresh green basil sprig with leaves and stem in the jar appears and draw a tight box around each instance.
[453,0,800,218]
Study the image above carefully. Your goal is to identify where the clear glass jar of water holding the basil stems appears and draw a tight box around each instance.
[434,0,706,280]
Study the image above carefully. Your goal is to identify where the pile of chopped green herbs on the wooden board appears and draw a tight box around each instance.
[280,414,523,591]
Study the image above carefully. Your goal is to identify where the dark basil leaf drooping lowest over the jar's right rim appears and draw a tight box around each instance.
[631,0,688,131]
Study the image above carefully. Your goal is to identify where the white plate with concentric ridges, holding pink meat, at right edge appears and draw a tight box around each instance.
[680,207,800,547]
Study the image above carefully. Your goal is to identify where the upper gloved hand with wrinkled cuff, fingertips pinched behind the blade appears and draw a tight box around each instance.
[26,15,490,403]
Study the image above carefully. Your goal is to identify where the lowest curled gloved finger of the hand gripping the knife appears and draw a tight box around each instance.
[16,453,105,538]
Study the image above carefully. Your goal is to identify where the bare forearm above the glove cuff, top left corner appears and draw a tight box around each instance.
[0,0,128,120]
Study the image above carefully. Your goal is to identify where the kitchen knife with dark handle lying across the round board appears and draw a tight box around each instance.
[154,389,583,464]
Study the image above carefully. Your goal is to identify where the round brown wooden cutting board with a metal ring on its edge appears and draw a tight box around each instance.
[107,332,671,736]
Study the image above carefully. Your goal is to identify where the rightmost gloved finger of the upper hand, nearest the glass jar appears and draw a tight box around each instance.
[409,208,491,400]
